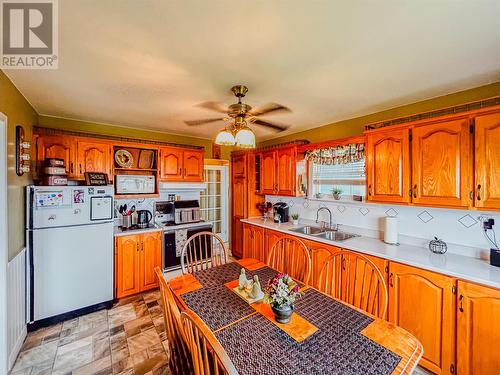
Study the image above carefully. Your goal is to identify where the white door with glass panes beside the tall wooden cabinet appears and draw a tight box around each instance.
[200,165,229,242]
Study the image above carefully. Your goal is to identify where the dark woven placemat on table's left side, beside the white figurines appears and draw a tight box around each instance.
[181,285,255,331]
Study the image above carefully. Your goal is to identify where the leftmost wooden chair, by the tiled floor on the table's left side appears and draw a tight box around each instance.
[155,267,193,375]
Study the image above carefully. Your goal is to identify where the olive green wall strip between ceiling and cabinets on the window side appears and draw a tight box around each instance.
[258,82,500,147]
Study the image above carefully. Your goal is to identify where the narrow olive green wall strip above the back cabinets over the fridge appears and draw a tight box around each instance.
[38,115,235,159]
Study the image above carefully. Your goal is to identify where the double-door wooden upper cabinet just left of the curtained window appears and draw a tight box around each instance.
[260,147,297,196]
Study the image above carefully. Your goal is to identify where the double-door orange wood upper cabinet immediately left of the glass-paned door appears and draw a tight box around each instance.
[160,147,204,182]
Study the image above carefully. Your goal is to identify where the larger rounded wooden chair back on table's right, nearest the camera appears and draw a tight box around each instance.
[317,250,388,318]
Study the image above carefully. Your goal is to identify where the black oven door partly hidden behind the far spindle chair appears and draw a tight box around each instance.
[163,225,212,271]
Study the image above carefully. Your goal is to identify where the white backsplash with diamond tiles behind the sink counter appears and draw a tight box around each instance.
[266,196,500,255]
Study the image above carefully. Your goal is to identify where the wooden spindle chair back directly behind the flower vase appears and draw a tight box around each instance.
[267,235,311,284]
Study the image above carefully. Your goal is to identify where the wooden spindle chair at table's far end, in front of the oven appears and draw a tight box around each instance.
[181,232,229,274]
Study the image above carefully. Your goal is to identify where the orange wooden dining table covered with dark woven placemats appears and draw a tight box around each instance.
[168,258,423,375]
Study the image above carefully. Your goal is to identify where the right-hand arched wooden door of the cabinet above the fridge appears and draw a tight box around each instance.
[77,141,112,180]
